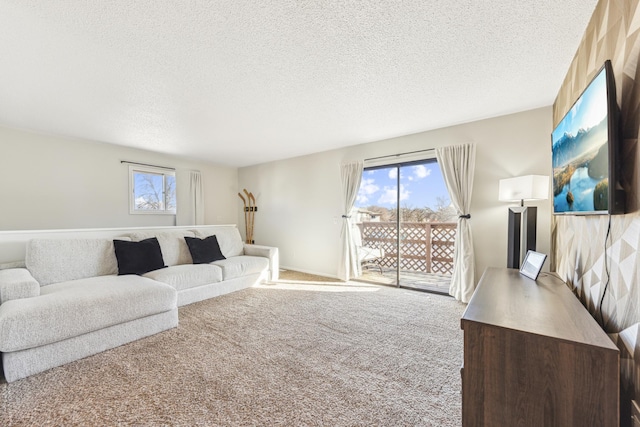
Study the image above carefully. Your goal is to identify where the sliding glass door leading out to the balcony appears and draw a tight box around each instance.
[352,159,456,293]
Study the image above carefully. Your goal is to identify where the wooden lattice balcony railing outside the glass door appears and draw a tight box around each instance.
[358,222,456,275]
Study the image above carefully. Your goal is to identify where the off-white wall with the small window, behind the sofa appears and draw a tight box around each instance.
[0,127,239,230]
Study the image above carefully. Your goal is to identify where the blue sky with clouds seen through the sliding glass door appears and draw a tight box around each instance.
[355,162,450,209]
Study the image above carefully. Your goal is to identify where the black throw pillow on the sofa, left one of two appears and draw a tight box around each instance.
[113,237,166,276]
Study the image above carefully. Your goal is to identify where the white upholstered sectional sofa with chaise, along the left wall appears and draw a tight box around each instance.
[0,226,278,382]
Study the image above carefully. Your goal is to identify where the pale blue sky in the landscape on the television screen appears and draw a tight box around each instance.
[553,66,607,142]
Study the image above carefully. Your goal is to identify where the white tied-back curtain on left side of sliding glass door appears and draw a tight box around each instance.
[338,161,364,281]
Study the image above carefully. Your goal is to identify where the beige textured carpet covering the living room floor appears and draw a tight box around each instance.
[0,275,464,426]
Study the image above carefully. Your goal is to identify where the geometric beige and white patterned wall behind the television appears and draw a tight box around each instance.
[552,0,640,418]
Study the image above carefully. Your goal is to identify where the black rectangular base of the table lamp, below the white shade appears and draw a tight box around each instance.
[507,206,538,268]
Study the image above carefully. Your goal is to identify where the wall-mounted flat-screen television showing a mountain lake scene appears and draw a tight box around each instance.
[551,60,625,215]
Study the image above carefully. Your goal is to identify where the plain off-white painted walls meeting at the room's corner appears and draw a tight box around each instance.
[0,107,551,276]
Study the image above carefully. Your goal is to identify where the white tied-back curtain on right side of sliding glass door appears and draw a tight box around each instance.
[436,144,476,303]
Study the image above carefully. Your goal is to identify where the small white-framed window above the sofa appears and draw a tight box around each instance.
[129,165,176,215]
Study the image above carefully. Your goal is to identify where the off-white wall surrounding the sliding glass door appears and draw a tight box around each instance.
[237,107,552,278]
